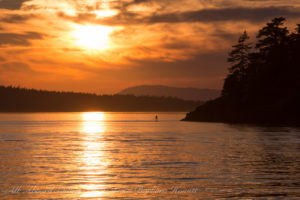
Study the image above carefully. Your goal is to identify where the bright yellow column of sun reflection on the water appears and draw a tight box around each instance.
[81,112,108,197]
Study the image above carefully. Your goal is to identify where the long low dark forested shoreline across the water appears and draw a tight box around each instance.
[0,86,201,112]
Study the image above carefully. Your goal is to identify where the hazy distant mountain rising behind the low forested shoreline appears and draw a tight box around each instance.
[118,85,221,101]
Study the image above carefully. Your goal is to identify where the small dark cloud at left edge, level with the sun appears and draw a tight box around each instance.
[0,32,43,47]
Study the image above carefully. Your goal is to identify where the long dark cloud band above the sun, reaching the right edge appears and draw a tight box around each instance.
[58,7,300,25]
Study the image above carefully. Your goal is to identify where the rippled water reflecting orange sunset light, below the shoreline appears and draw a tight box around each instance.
[0,113,300,199]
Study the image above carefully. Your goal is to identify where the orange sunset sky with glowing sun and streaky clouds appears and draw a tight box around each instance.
[0,0,300,94]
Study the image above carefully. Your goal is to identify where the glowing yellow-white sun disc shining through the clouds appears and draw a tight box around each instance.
[72,25,112,50]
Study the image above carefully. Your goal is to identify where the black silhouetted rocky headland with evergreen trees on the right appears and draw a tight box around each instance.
[184,17,300,124]
